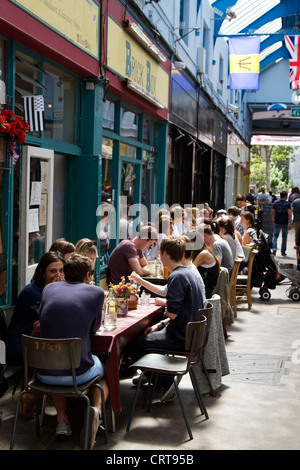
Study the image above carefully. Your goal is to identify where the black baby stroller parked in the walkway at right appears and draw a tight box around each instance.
[251,230,285,300]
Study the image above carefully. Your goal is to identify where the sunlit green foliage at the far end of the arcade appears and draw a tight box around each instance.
[250,145,294,193]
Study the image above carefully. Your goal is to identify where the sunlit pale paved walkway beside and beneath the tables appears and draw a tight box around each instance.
[0,231,300,456]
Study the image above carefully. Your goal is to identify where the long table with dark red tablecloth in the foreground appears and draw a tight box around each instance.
[90,300,163,413]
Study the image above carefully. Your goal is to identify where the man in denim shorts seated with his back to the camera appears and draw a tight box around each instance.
[39,254,108,449]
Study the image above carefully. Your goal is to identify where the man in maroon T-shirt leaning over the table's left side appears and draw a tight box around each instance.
[107,225,157,284]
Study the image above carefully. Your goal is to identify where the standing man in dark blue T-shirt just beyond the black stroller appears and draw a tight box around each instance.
[271,191,293,256]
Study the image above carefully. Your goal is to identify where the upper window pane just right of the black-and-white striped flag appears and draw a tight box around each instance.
[44,64,78,144]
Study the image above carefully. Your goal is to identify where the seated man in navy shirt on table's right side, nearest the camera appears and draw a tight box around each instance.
[128,237,203,402]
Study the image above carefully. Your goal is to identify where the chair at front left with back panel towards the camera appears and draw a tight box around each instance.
[10,335,108,450]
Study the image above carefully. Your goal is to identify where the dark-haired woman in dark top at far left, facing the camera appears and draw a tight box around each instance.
[6,251,64,366]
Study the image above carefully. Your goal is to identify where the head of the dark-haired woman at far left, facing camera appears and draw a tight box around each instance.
[33,251,65,289]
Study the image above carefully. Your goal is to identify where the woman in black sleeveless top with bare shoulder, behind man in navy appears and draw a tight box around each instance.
[188,232,220,299]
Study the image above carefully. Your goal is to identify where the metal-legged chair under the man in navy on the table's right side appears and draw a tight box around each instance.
[126,315,208,439]
